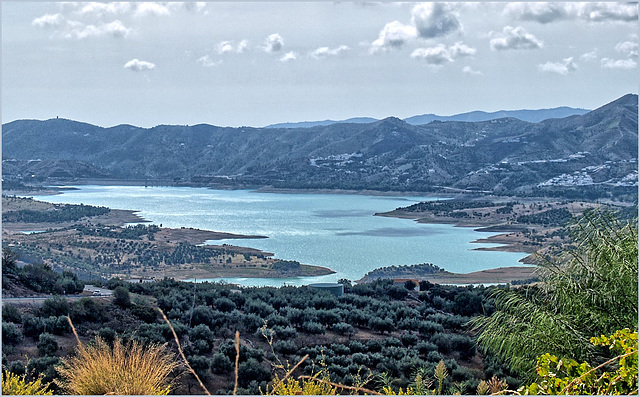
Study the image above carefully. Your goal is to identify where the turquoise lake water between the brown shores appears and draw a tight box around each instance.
[34,186,527,286]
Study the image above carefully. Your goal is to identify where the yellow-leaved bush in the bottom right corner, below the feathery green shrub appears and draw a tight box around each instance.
[518,329,638,395]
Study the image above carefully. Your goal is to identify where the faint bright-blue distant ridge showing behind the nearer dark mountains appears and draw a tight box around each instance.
[265,106,589,128]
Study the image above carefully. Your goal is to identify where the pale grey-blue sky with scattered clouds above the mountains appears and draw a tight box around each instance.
[1,1,638,127]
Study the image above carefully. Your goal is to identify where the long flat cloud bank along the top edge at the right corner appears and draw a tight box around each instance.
[504,2,638,23]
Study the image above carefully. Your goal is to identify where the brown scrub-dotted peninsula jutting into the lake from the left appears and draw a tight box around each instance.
[2,196,334,279]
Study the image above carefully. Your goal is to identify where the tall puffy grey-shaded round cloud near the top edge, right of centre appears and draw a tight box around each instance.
[411,3,461,39]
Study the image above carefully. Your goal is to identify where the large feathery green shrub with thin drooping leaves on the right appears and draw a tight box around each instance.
[472,211,638,373]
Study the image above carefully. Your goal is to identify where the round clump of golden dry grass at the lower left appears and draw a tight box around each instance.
[56,337,179,395]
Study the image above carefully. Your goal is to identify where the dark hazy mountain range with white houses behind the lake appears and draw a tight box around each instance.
[2,94,638,197]
